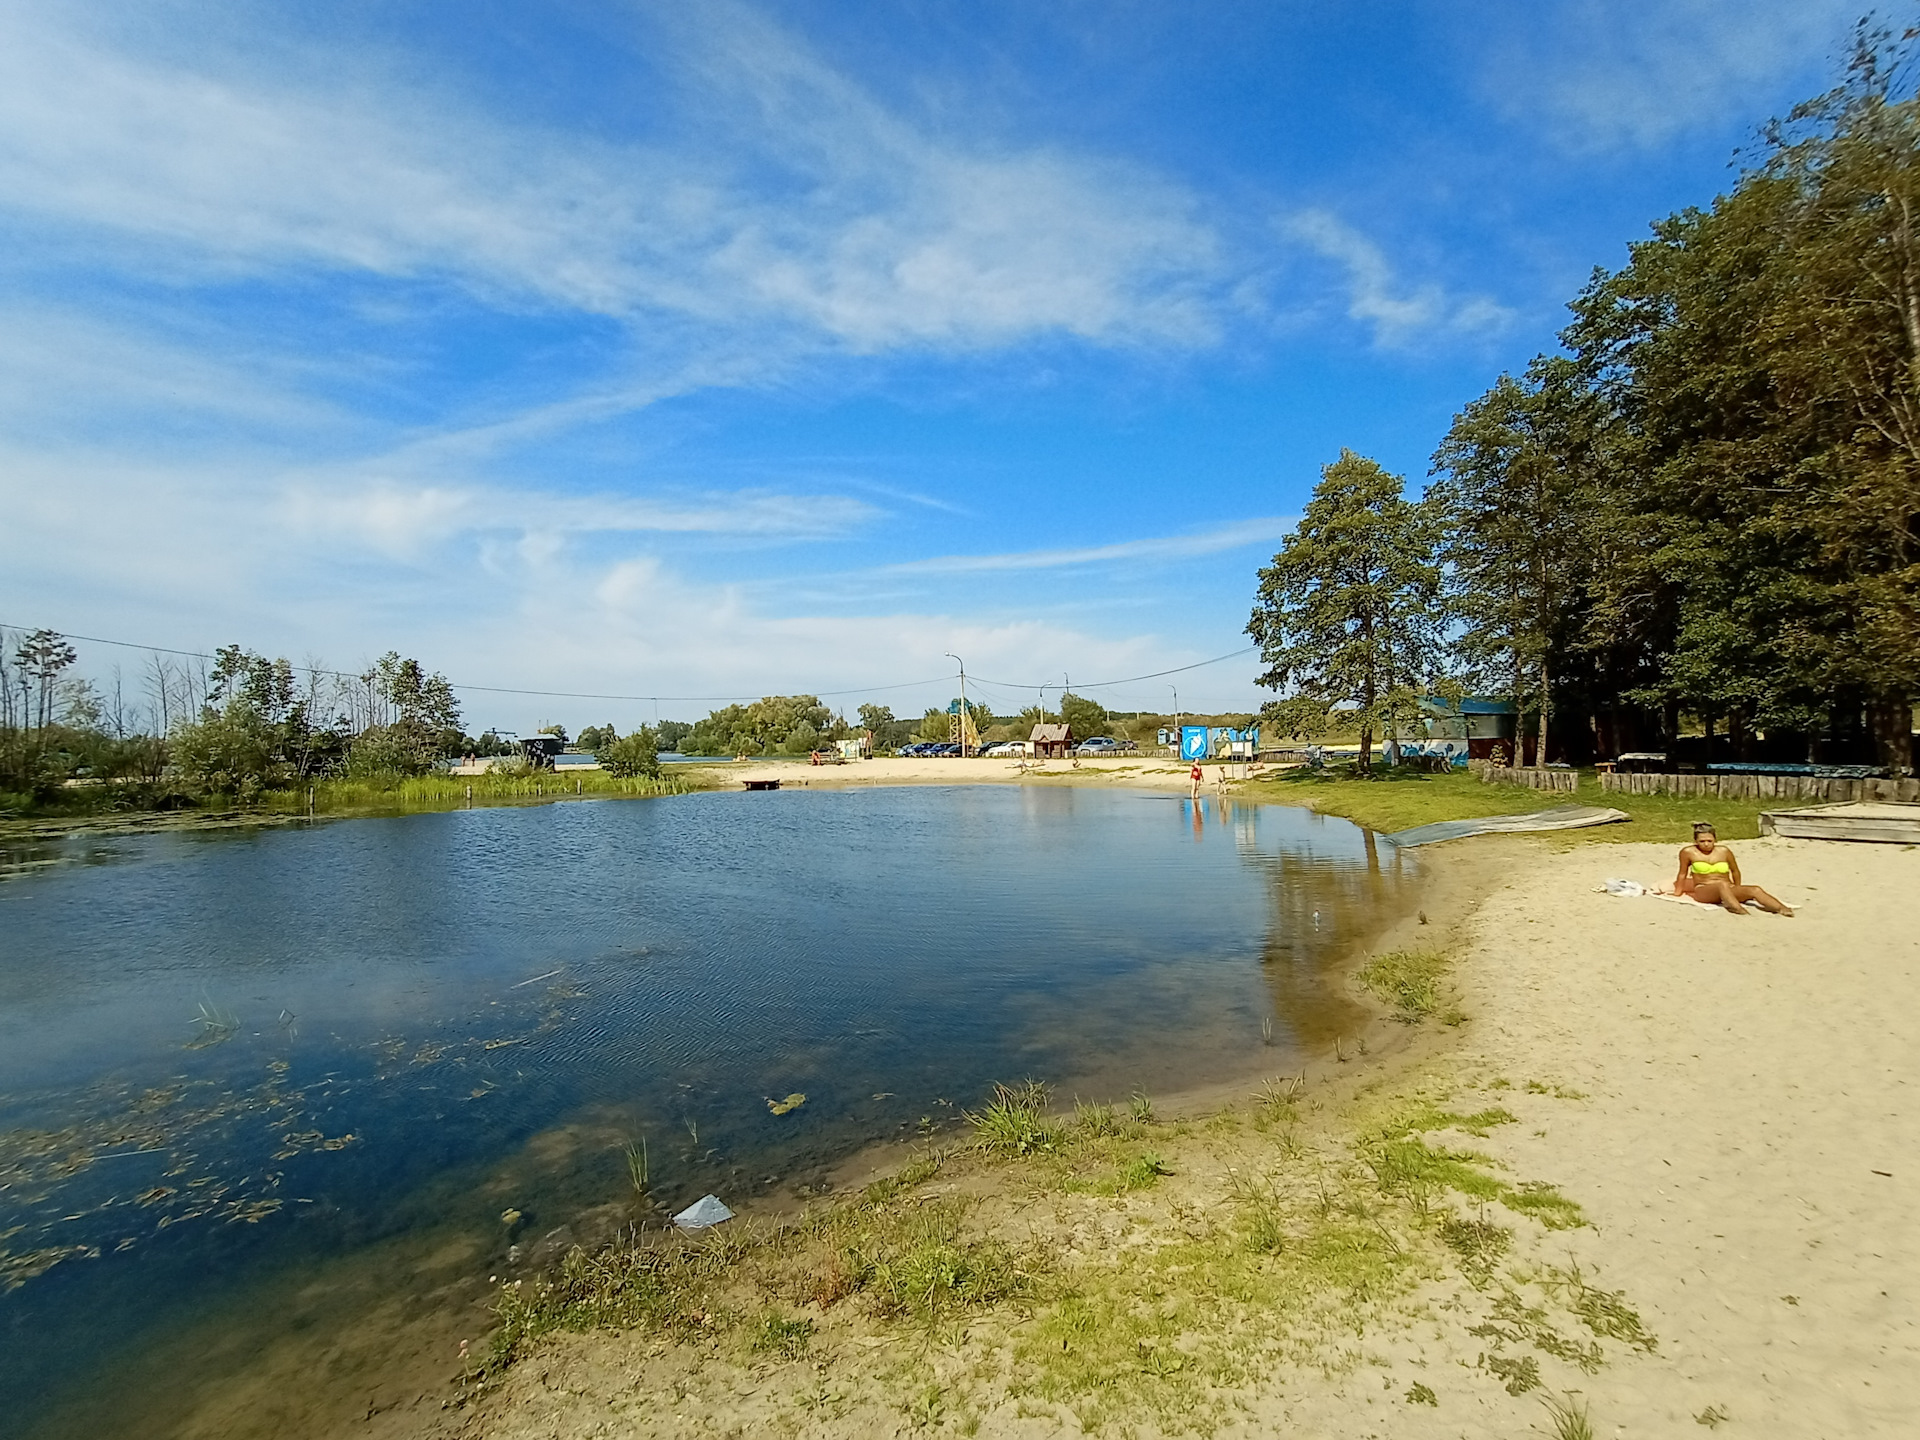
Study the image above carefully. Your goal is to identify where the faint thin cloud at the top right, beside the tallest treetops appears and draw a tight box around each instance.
[1465,0,1870,154]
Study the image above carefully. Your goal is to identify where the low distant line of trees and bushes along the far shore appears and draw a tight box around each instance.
[0,628,1213,814]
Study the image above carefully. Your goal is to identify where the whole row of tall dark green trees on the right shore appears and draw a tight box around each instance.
[1248,25,1920,770]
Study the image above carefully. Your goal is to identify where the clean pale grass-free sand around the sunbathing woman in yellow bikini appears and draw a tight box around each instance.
[1450,839,1920,1436]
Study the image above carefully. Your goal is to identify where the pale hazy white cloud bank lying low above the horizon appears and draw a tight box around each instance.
[0,449,1254,728]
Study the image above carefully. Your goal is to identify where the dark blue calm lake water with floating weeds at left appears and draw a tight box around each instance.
[0,787,1407,1436]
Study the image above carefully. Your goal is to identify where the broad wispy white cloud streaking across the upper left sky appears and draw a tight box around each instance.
[0,8,1219,349]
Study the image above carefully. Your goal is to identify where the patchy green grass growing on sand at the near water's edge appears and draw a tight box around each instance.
[472,1081,1651,1434]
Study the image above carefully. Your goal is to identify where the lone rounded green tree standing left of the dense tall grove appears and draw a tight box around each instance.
[1246,449,1444,772]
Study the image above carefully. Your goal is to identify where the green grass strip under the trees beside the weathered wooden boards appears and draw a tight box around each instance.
[1242,768,1814,847]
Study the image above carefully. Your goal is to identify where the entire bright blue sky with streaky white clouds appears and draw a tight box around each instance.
[0,0,1859,728]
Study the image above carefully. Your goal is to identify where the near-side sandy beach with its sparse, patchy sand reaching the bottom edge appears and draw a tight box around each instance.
[456,821,1920,1438]
